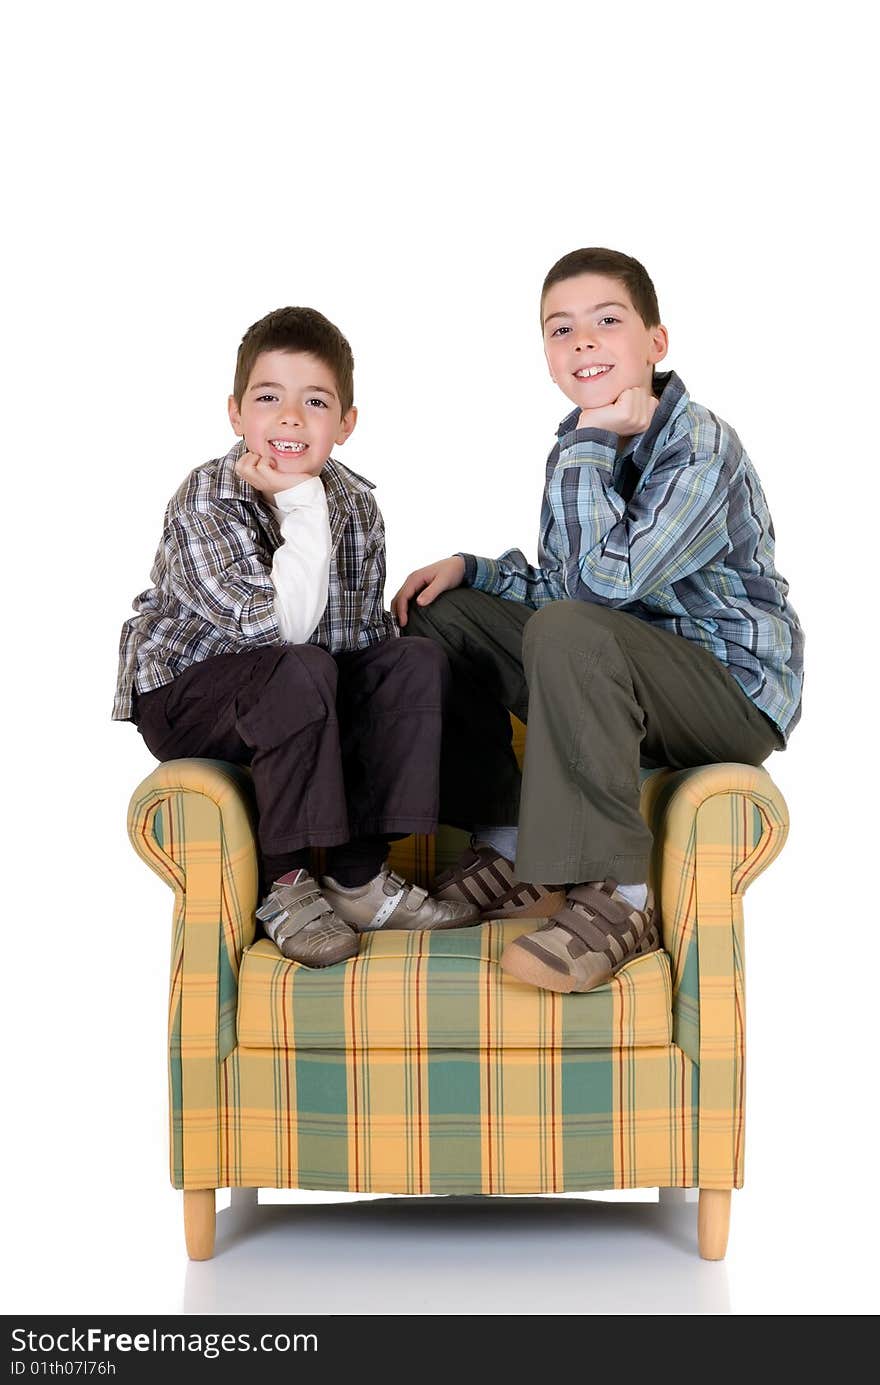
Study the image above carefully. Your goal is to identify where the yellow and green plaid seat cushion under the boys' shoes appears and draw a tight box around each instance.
[238,918,672,1051]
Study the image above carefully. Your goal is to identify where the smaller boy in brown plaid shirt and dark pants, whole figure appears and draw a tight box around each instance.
[114,307,479,967]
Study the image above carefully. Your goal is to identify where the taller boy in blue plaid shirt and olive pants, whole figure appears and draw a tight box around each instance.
[392,249,802,992]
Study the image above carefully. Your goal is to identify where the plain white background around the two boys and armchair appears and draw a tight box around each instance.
[1,0,879,1313]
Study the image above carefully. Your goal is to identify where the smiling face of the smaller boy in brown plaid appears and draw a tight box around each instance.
[229,350,358,476]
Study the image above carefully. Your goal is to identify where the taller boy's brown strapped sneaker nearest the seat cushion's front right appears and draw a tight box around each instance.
[502,879,660,993]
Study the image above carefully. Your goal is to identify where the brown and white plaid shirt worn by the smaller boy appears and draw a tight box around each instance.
[112,442,398,722]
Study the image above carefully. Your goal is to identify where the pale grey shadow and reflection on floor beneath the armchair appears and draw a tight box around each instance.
[183,1197,730,1316]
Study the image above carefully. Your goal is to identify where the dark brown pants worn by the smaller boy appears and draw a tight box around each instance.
[134,640,449,856]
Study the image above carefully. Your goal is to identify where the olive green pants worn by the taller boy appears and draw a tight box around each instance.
[405,587,783,885]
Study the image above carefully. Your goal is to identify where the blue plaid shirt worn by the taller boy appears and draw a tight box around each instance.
[461,371,804,740]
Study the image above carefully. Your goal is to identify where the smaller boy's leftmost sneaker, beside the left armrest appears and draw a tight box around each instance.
[256,870,360,967]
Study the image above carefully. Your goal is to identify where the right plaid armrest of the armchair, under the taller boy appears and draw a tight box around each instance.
[642,765,789,1188]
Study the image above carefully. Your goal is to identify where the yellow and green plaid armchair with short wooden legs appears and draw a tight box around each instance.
[129,723,787,1259]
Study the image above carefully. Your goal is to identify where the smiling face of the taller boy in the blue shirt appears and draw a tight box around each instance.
[540,274,669,409]
